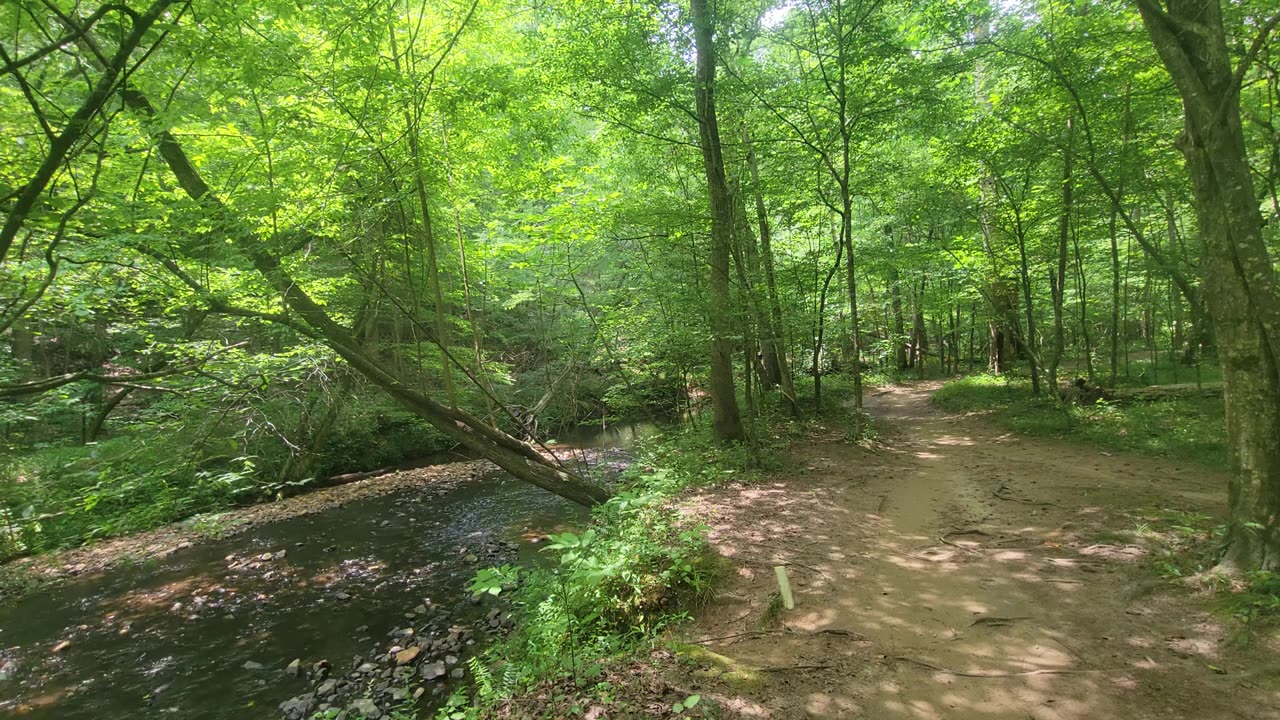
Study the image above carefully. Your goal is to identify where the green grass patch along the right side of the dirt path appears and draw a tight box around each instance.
[933,375,1226,469]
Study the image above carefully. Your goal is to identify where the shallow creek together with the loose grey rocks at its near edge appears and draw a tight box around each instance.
[0,420,660,720]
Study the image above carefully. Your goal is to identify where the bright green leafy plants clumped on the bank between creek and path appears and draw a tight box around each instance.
[438,432,722,720]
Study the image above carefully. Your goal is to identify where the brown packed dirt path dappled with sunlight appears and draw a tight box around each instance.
[673,383,1280,720]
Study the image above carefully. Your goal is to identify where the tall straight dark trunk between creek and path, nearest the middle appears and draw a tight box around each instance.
[690,0,746,442]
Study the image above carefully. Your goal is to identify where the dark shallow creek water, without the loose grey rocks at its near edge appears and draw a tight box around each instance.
[0,417,654,720]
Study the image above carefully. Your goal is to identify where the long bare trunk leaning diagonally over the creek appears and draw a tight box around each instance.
[124,88,609,506]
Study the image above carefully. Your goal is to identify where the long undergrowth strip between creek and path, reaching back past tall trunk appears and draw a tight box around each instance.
[430,375,873,720]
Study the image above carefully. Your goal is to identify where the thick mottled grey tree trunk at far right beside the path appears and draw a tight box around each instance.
[1138,0,1280,570]
